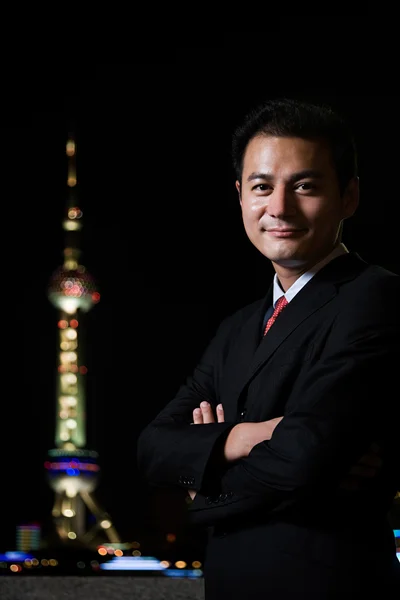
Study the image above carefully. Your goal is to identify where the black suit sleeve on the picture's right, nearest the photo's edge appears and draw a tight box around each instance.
[189,277,400,525]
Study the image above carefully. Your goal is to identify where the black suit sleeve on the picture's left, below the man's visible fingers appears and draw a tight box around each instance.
[137,318,238,490]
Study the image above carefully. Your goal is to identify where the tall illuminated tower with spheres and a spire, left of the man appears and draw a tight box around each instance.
[45,134,120,548]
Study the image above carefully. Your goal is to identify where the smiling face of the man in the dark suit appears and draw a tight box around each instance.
[236,135,358,270]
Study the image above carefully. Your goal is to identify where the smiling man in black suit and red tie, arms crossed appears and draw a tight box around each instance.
[138,99,400,600]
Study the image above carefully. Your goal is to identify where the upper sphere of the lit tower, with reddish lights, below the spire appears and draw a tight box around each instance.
[48,265,100,313]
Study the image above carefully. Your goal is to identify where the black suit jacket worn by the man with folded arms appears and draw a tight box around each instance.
[138,253,400,600]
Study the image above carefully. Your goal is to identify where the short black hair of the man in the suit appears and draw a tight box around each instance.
[232,98,357,193]
